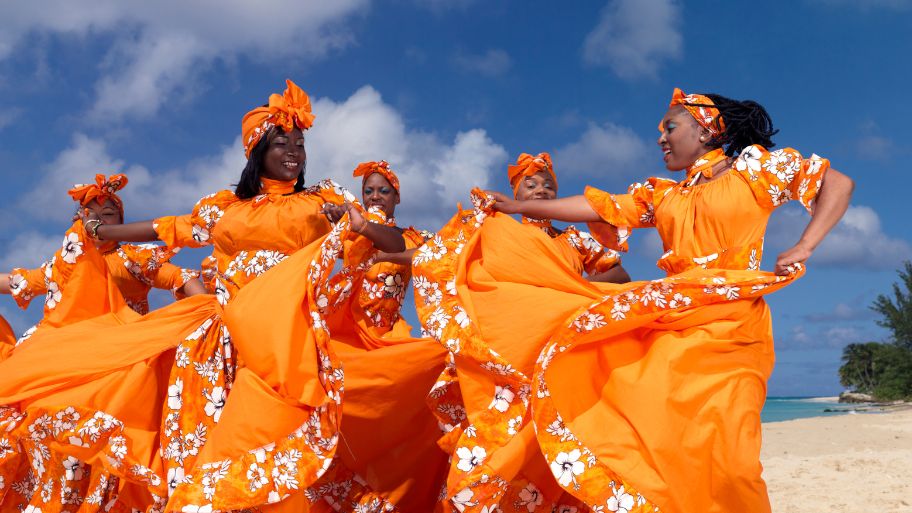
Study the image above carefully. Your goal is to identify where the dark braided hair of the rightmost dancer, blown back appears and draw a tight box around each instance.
[687,94,779,157]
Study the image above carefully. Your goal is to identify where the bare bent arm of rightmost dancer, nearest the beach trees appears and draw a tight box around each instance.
[775,168,855,274]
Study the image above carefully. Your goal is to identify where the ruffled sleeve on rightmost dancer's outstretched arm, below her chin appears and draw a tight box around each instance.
[584,177,677,251]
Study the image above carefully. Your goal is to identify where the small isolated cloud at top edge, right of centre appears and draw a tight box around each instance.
[583,0,684,80]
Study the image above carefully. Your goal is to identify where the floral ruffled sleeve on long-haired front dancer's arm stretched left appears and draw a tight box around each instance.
[152,190,238,248]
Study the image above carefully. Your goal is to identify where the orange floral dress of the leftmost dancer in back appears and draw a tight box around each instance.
[10,239,199,340]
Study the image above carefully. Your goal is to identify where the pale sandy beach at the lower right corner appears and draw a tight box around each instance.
[762,404,912,513]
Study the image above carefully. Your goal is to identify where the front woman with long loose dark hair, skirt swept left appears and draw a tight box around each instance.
[0,81,404,510]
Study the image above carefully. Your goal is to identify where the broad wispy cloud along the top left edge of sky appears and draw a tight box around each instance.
[0,0,369,120]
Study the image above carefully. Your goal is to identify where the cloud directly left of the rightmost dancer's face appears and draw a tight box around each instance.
[554,122,658,179]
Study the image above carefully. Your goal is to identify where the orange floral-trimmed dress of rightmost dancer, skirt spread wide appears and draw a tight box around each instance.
[414,146,828,512]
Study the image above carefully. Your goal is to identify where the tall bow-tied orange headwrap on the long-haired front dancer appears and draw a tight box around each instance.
[241,80,315,158]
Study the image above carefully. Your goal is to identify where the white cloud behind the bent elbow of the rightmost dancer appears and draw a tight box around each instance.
[767,205,912,270]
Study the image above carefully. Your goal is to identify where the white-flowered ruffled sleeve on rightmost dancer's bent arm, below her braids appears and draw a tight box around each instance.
[735,145,830,213]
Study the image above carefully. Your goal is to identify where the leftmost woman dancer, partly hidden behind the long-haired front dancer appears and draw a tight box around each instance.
[0,174,206,340]
